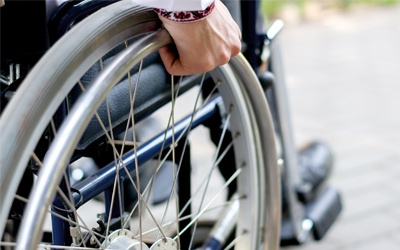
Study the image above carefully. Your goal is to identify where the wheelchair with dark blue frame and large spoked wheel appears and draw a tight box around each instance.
[0,0,341,249]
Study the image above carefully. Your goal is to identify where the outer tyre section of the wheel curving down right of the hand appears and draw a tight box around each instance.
[229,55,281,249]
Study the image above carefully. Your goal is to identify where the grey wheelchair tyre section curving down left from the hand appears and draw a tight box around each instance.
[0,1,161,238]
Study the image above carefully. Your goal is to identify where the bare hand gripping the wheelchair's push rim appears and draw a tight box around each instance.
[159,0,241,75]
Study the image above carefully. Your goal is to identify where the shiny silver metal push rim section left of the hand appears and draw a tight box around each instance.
[16,30,172,250]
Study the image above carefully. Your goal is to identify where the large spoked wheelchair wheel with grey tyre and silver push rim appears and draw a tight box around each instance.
[0,1,281,249]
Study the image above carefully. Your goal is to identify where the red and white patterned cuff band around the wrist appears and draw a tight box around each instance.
[154,2,215,23]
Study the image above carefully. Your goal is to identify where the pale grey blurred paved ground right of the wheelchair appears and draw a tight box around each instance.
[281,3,400,250]
